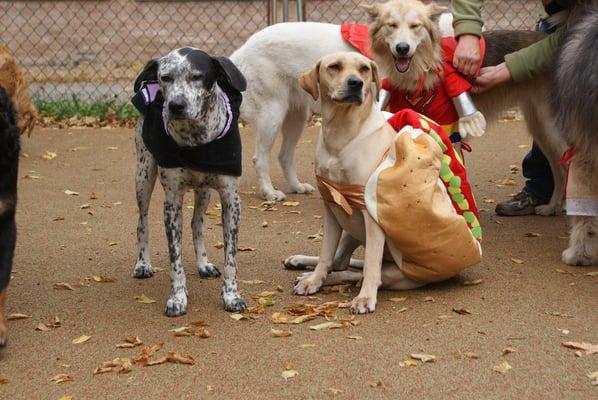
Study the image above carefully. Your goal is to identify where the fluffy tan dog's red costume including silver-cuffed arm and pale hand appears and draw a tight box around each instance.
[341,24,486,148]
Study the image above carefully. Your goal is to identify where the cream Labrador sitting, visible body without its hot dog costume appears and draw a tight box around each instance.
[294,52,423,314]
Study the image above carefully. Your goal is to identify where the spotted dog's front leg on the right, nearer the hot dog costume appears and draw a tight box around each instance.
[218,177,247,312]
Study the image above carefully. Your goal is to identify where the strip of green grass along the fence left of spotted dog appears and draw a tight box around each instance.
[33,96,139,122]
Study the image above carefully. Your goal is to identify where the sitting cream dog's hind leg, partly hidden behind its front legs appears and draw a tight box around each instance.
[282,231,363,271]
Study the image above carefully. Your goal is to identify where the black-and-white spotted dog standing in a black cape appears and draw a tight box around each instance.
[132,48,246,317]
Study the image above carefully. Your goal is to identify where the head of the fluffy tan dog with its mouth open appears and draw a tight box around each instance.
[361,0,446,91]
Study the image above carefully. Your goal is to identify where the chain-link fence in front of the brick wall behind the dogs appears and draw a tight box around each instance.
[0,0,542,100]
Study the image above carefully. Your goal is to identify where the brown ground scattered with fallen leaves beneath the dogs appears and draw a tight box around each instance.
[0,121,598,399]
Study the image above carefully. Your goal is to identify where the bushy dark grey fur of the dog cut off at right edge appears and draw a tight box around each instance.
[553,0,598,168]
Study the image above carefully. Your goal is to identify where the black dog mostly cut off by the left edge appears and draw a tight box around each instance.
[0,87,19,346]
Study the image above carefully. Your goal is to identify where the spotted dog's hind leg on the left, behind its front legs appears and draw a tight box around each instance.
[133,122,158,278]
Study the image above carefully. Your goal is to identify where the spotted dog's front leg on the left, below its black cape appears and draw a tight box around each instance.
[160,180,187,317]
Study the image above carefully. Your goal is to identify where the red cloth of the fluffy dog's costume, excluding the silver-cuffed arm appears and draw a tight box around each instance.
[341,24,485,143]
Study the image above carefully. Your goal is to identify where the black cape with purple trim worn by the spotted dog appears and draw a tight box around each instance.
[131,82,242,176]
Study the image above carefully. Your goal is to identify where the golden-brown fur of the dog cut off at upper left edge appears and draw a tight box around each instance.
[0,45,37,134]
